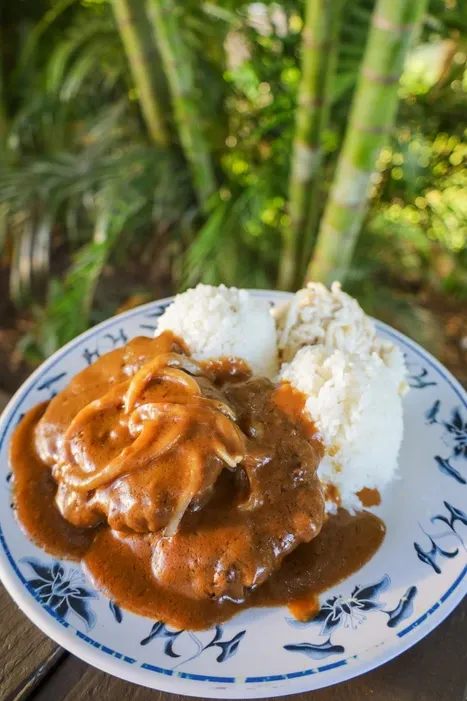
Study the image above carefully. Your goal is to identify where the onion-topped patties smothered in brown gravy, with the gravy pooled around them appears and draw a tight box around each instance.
[11,331,384,629]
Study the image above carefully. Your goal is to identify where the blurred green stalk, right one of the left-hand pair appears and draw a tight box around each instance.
[148,0,216,207]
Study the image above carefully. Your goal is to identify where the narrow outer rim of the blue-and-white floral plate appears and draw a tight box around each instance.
[0,290,467,698]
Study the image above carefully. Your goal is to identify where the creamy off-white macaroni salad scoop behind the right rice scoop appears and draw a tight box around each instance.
[274,282,375,362]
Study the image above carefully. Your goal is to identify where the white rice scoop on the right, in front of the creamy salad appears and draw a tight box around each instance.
[280,342,405,510]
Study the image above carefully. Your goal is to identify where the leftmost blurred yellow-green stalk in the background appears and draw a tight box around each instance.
[112,0,170,146]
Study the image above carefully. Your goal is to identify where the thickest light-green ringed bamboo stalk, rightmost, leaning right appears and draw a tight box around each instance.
[307,0,427,283]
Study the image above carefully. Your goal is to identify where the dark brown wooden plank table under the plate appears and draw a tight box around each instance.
[0,393,467,701]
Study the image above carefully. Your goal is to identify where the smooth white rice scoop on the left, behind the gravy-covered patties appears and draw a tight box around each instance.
[156,285,278,378]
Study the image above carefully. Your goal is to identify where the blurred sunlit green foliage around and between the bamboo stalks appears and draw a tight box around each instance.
[0,0,467,356]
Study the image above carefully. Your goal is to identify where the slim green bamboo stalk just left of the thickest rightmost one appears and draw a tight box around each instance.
[279,0,343,289]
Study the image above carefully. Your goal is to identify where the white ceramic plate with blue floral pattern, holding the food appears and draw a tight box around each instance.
[0,292,467,698]
